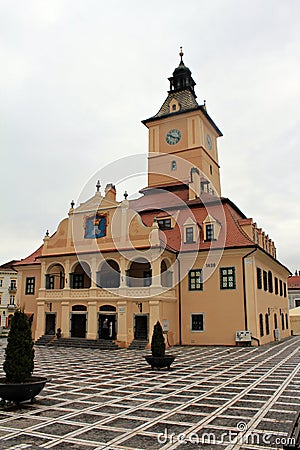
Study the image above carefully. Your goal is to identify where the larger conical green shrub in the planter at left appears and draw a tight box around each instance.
[3,310,34,383]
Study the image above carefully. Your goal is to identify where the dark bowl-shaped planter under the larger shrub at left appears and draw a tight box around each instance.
[0,377,50,403]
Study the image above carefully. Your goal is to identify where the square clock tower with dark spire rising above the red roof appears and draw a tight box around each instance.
[143,48,222,195]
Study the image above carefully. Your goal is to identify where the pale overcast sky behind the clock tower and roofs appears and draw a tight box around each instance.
[0,0,300,272]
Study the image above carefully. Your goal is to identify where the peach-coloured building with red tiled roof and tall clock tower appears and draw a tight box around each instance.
[14,50,291,348]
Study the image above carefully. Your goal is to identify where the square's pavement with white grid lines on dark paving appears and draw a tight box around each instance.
[0,337,300,450]
